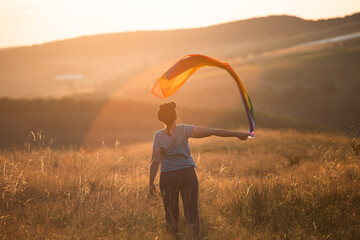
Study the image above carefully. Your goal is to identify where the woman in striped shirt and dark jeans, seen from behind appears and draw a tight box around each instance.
[149,102,248,237]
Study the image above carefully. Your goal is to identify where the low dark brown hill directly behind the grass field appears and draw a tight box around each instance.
[0,99,336,150]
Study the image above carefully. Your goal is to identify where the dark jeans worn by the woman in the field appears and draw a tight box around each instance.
[160,167,199,236]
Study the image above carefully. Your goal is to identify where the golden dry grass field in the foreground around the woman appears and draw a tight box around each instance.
[0,130,360,239]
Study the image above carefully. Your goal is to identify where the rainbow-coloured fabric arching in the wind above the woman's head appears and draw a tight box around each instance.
[151,54,255,137]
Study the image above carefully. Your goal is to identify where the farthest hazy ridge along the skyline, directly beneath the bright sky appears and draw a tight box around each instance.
[2,13,360,57]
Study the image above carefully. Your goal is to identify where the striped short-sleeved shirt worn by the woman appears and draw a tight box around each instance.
[153,124,196,172]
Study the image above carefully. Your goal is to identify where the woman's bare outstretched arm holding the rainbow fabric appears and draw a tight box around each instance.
[192,126,249,140]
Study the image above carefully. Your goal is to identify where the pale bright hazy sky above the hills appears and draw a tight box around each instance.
[0,0,360,47]
